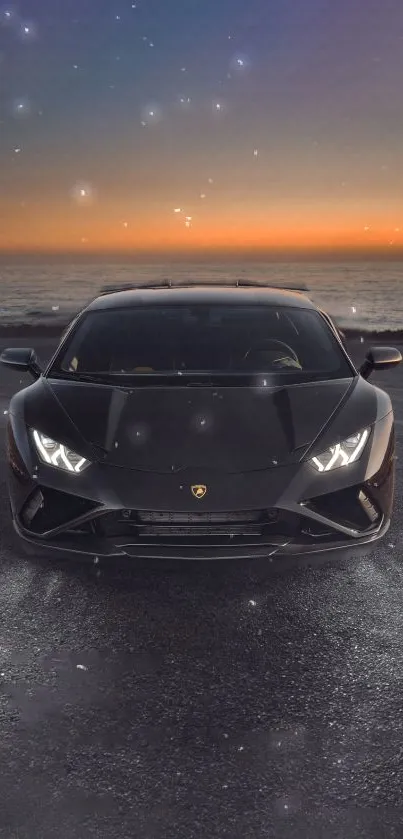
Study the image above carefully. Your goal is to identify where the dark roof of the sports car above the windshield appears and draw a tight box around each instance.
[87,283,317,311]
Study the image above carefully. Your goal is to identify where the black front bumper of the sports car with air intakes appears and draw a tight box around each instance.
[9,410,395,560]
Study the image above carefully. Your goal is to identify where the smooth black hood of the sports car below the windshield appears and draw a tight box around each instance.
[25,379,360,473]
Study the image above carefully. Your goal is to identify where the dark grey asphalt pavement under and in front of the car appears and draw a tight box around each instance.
[0,340,403,839]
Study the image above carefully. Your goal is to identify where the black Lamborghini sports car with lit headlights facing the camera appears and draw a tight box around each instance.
[1,282,401,559]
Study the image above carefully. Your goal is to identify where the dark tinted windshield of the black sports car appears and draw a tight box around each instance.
[50,304,352,381]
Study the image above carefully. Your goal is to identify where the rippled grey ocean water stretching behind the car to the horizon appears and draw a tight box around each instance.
[0,262,403,331]
